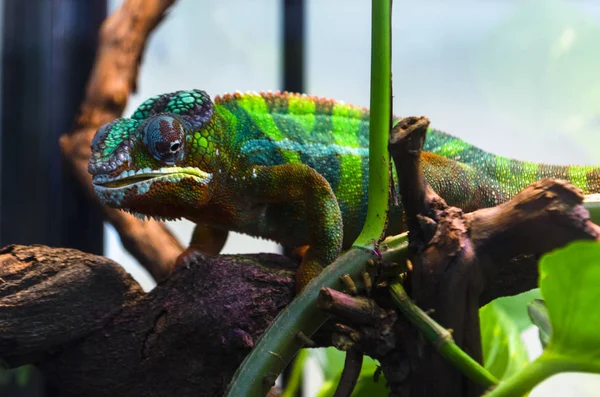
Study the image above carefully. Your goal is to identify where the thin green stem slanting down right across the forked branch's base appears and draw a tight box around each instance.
[390,282,498,386]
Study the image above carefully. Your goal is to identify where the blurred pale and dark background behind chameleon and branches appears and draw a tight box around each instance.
[0,0,600,397]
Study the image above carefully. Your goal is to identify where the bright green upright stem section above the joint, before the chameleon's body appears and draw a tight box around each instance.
[354,0,392,249]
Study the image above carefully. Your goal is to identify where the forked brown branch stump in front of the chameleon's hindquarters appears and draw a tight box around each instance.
[382,117,600,396]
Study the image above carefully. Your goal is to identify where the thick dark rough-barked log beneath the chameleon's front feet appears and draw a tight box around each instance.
[0,245,295,397]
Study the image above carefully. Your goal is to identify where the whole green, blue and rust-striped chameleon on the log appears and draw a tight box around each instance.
[88,90,600,289]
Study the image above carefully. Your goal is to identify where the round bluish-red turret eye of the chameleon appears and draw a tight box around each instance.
[144,115,185,164]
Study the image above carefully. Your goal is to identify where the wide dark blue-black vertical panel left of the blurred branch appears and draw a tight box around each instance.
[0,0,106,254]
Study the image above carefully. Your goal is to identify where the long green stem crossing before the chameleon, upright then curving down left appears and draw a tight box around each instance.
[225,0,394,397]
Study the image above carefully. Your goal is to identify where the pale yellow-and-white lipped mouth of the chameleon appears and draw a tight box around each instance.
[92,167,212,190]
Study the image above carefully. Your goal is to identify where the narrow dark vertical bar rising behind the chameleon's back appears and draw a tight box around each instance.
[283,0,305,92]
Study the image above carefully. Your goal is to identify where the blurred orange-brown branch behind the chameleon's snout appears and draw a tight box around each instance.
[60,0,183,280]
